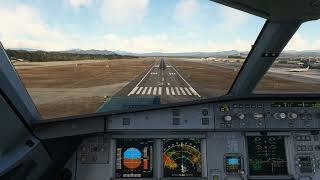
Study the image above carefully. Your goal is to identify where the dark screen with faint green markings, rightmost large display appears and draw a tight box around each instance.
[247,136,288,175]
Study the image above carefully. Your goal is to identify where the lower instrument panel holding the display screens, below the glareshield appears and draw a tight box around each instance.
[66,131,320,180]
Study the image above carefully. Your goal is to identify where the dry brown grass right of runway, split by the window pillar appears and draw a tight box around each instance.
[170,60,320,97]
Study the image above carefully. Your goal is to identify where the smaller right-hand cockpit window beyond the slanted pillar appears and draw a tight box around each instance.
[255,20,320,93]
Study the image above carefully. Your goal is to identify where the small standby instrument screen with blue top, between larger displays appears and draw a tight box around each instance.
[224,154,242,174]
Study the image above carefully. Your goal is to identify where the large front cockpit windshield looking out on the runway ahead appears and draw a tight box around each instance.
[0,0,265,119]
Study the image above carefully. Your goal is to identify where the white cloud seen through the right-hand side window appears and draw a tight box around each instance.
[285,32,320,51]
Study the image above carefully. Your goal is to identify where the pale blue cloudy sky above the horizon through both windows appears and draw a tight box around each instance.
[0,0,320,52]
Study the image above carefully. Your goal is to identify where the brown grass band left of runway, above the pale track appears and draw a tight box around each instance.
[17,59,152,88]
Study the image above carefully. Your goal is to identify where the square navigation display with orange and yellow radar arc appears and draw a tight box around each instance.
[163,138,202,177]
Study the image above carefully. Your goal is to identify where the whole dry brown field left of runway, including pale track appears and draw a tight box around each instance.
[16,58,153,119]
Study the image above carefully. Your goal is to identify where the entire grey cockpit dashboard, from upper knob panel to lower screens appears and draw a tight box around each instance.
[59,100,320,180]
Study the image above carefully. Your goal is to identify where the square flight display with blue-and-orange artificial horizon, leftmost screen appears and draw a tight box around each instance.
[116,139,153,178]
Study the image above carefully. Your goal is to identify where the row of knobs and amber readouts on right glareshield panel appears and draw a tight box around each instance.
[215,101,320,130]
